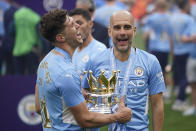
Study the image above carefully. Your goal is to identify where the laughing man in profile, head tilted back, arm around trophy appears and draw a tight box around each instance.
[35,10,131,131]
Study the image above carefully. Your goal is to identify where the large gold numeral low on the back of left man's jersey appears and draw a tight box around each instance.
[41,98,52,128]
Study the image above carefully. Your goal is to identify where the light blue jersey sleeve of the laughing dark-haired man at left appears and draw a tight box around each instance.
[55,72,85,107]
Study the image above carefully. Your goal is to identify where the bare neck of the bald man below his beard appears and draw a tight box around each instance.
[114,47,131,62]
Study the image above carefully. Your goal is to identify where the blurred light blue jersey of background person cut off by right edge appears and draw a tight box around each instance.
[184,22,196,58]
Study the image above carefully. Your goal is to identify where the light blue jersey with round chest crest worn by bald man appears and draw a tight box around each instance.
[84,48,165,131]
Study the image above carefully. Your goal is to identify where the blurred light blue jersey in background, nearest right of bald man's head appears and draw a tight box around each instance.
[144,13,172,52]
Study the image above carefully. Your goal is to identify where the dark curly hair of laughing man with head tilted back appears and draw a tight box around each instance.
[39,9,67,42]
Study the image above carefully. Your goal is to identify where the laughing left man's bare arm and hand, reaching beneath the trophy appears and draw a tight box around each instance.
[70,97,132,128]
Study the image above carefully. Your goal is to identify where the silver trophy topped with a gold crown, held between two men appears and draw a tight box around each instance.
[85,70,120,114]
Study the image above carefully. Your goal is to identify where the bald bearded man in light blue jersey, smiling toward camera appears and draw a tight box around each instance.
[84,11,165,131]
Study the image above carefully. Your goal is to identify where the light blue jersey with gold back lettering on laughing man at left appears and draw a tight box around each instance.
[37,47,84,131]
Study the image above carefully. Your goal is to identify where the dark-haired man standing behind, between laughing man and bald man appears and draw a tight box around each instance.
[69,8,106,131]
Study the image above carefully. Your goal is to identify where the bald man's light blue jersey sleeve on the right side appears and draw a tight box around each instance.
[149,56,165,95]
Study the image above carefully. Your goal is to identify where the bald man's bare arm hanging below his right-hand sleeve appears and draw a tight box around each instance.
[150,93,164,131]
